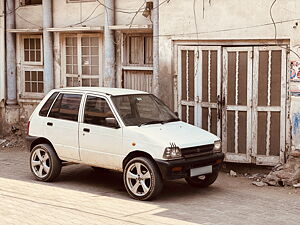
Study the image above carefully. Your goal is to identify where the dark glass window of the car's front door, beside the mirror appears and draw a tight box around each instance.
[84,96,115,127]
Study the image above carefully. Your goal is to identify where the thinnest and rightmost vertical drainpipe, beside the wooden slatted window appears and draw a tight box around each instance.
[152,0,159,97]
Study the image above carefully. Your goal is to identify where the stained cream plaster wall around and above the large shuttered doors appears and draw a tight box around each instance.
[160,0,300,106]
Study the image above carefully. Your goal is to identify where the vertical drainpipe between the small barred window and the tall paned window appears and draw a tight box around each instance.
[43,0,54,93]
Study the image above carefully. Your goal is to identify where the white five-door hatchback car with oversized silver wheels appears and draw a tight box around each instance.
[27,87,224,200]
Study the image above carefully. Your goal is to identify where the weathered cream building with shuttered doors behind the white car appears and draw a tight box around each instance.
[1,0,300,165]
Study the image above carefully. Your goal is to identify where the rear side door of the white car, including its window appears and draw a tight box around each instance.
[45,92,83,160]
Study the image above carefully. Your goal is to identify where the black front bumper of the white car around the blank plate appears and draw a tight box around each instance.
[155,153,224,180]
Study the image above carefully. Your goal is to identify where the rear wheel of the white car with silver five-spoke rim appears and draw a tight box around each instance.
[30,144,62,182]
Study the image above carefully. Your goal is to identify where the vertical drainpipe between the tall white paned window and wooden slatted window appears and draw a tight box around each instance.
[103,0,116,87]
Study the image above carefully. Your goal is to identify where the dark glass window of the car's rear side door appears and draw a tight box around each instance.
[49,94,82,121]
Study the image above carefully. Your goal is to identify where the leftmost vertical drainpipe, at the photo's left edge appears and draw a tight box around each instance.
[6,0,17,105]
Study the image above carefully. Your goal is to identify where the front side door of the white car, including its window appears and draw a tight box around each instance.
[79,95,122,169]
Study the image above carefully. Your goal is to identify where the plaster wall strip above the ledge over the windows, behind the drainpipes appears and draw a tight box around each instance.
[16,0,151,28]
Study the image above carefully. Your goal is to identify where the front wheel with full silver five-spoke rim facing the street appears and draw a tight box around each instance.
[123,157,163,200]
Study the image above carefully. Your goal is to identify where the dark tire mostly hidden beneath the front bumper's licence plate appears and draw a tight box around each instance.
[185,171,219,188]
